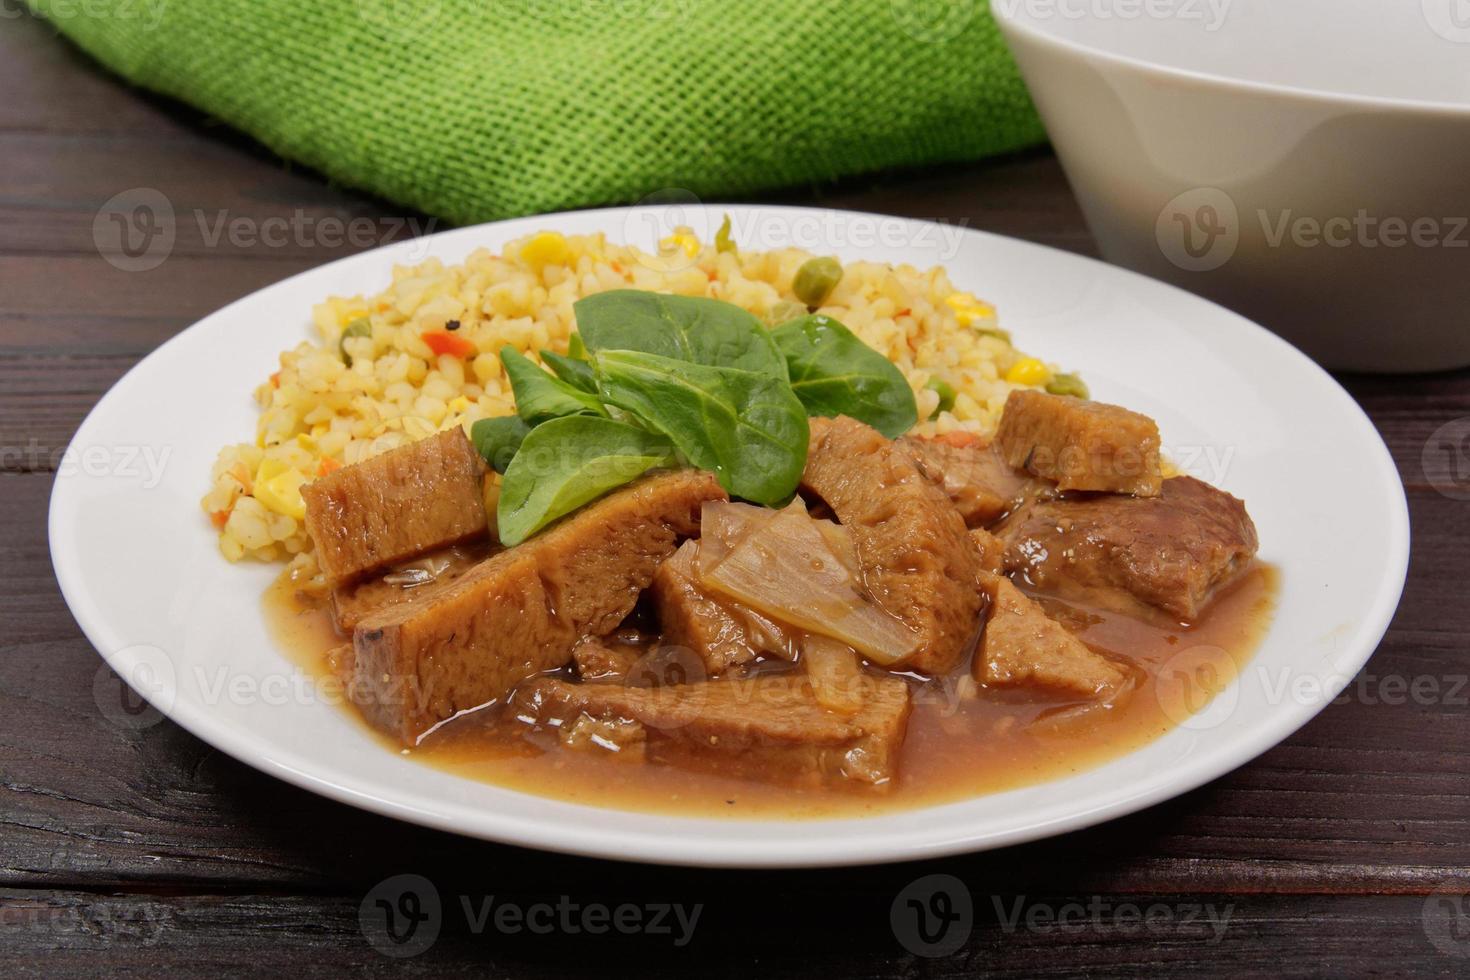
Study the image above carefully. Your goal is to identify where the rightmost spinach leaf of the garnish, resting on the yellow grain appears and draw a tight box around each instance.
[770,314,919,439]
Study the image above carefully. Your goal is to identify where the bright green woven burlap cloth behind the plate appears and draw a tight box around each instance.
[28,0,1042,223]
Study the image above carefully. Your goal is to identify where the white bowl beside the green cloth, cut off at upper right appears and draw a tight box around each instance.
[991,0,1470,372]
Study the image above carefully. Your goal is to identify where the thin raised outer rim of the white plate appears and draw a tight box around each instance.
[47,201,1411,868]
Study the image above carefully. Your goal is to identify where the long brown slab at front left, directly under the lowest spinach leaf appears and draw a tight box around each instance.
[353,470,725,742]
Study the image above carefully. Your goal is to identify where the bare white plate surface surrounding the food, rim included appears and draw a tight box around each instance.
[50,206,1408,867]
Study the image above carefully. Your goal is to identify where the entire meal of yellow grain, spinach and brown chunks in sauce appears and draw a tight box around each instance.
[203,231,1270,813]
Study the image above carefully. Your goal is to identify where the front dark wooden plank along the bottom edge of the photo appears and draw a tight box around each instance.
[0,879,1470,979]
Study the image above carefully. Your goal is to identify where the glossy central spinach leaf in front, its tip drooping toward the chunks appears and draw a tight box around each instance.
[592,351,811,504]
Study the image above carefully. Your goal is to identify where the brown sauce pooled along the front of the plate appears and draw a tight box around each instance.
[265,564,1277,820]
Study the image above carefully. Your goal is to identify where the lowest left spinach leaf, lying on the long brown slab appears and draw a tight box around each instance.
[495,416,679,545]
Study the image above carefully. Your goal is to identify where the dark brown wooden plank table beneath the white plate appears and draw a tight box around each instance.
[0,11,1470,977]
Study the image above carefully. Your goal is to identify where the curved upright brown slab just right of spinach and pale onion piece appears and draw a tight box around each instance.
[801,416,983,674]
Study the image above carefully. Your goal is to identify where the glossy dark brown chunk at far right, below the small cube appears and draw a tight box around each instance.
[997,476,1257,620]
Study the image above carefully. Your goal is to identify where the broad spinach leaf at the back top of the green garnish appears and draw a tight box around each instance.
[572,289,786,381]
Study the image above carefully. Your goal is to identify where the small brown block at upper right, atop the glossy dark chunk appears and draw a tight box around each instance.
[995,389,1163,497]
